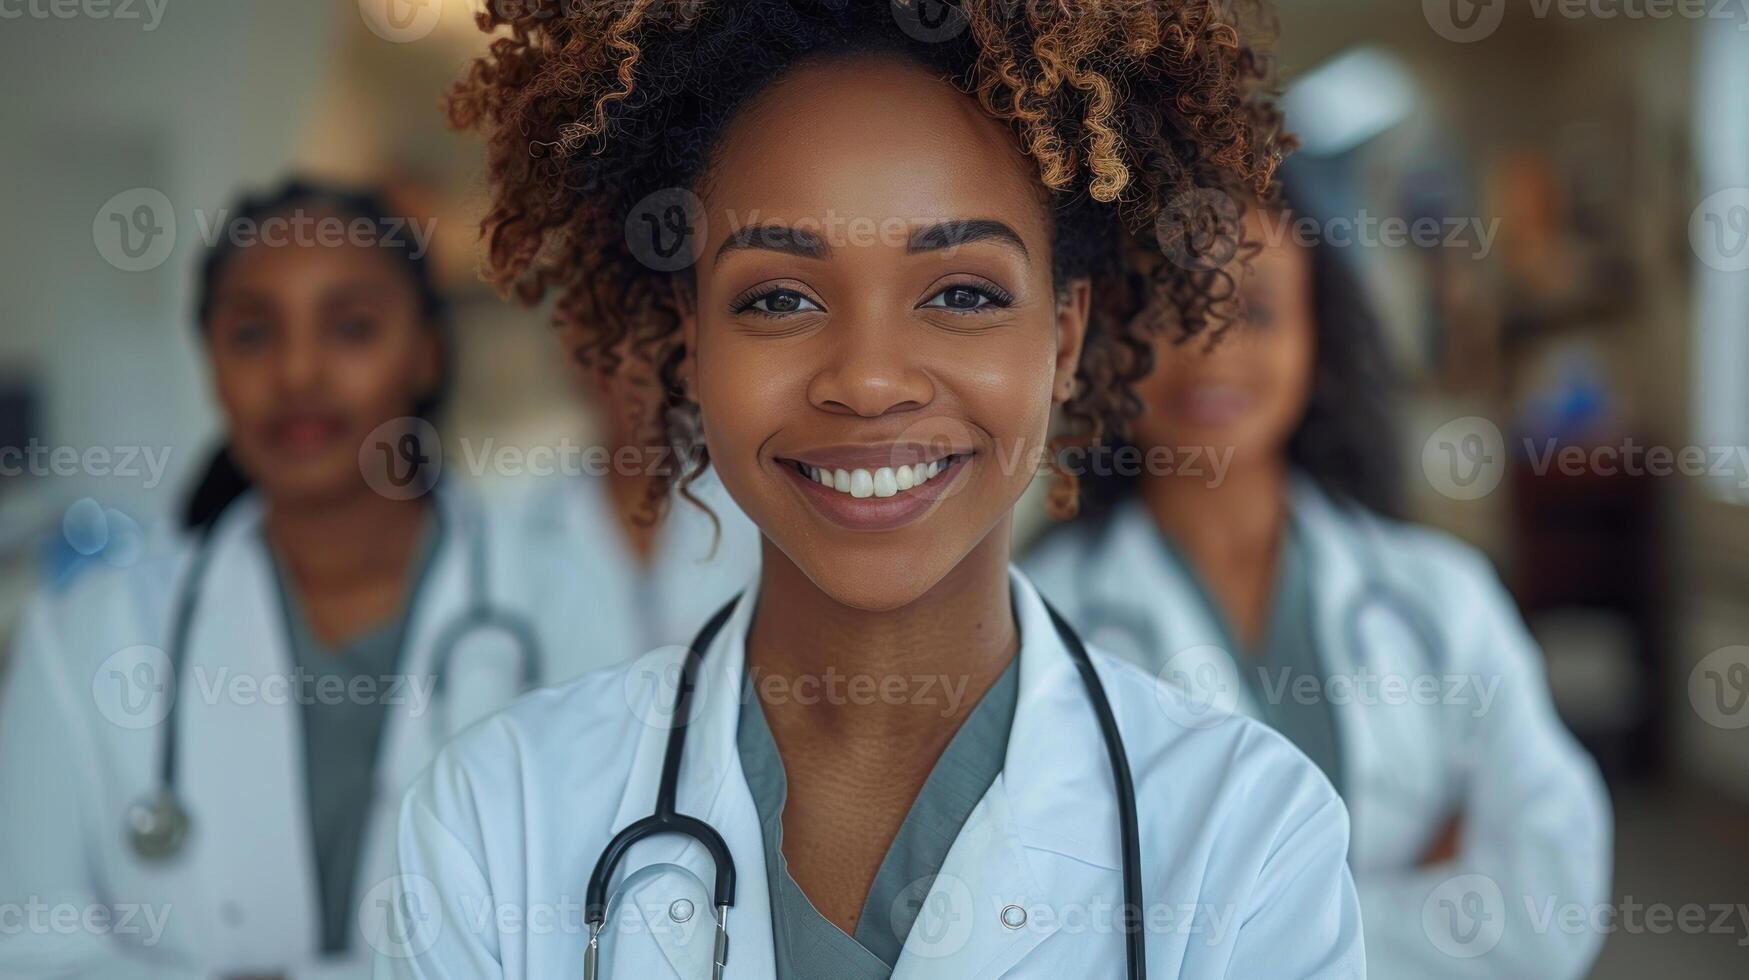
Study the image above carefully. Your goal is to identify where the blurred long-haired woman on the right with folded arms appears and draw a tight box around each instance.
[1025,189,1611,978]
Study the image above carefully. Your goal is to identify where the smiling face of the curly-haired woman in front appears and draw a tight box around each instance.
[687,60,1088,609]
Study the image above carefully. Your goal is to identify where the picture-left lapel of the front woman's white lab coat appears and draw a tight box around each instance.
[603,586,777,980]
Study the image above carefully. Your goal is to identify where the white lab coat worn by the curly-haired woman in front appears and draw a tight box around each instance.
[378,572,1366,980]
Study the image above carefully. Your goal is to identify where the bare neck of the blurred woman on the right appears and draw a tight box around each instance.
[1142,457,1287,564]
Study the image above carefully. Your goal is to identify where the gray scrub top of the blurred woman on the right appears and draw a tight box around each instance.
[1167,520,1343,793]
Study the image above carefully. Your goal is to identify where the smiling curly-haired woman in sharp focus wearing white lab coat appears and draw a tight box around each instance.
[378,7,1364,980]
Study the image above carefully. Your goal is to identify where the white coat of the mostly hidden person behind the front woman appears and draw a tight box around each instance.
[488,471,759,672]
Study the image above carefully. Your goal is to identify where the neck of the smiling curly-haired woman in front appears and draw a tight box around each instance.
[747,518,1020,744]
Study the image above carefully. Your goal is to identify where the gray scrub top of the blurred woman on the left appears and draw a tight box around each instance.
[269,515,442,952]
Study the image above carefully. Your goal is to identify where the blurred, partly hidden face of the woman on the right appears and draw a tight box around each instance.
[1132,208,1315,476]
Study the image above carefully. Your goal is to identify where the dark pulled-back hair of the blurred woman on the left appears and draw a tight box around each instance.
[182,177,455,532]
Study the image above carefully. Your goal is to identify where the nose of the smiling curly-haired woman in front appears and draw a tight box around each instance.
[808,317,936,418]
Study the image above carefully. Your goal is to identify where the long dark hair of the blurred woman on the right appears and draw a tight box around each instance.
[1081,177,1403,522]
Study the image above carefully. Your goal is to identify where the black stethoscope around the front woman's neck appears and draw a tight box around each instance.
[582,595,1147,980]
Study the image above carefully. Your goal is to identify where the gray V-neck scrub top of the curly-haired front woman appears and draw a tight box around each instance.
[735,656,1020,980]
